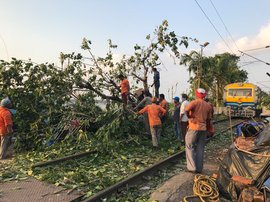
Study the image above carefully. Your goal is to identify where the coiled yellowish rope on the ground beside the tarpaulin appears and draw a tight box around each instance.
[184,175,220,202]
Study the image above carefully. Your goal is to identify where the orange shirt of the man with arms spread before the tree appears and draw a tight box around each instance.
[139,103,166,127]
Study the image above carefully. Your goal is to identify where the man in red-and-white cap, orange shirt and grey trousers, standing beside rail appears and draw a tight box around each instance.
[185,88,212,173]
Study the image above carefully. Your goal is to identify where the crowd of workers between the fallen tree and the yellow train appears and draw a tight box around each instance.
[119,68,214,173]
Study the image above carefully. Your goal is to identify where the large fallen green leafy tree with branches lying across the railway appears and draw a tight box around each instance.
[0,20,196,150]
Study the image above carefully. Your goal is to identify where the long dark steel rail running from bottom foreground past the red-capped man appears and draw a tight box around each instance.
[79,120,243,202]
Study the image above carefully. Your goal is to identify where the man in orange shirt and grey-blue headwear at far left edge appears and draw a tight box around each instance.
[0,98,13,159]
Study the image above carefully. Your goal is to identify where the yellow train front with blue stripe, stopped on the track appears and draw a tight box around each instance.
[224,83,258,117]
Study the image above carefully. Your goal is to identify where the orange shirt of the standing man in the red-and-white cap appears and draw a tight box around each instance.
[185,98,212,130]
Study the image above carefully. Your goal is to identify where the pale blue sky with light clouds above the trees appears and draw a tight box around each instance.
[0,0,270,100]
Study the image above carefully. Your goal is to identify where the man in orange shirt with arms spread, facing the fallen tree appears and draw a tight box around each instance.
[138,97,166,147]
